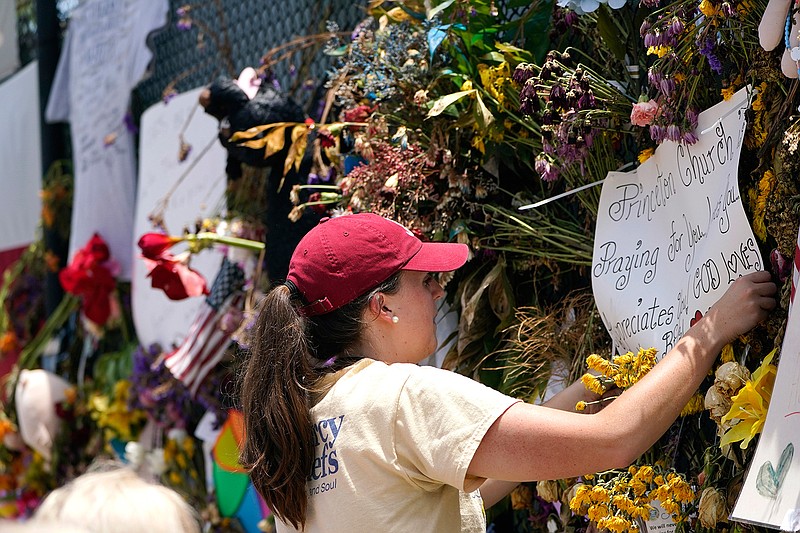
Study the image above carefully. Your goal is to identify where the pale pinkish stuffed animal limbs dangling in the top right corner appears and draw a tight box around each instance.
[758,0,800,78]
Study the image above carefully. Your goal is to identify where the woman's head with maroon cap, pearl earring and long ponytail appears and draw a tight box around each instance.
[241,213,469,526]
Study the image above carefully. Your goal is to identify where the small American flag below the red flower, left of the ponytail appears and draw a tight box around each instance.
[164,258,245,396]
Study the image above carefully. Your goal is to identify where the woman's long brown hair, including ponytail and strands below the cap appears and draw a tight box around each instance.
[241,272,400,529]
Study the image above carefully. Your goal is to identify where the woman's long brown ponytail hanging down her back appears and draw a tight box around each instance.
[241,285,316,529]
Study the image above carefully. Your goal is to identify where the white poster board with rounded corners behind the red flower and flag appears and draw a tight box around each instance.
[131,89,227,349]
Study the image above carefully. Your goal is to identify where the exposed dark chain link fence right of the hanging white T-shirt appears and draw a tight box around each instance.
[133,0,366,115]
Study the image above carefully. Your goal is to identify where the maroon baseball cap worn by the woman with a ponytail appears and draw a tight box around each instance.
[286,213,469,316]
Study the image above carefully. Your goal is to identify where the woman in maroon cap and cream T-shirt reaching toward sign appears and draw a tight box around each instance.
[242,210,776,532]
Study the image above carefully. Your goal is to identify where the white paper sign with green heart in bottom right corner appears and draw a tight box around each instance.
[731,227,800,531]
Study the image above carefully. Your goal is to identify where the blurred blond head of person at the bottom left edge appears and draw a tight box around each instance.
[32,466,200,533]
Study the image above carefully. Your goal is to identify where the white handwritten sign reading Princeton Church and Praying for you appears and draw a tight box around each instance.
[591,89,762,354]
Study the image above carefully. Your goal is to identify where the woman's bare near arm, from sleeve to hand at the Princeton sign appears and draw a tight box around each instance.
[468,272,776,481]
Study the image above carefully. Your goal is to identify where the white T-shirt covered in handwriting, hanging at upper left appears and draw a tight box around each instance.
[45,0,169,280]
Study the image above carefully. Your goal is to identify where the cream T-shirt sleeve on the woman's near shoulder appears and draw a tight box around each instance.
[394,367,519,490]
